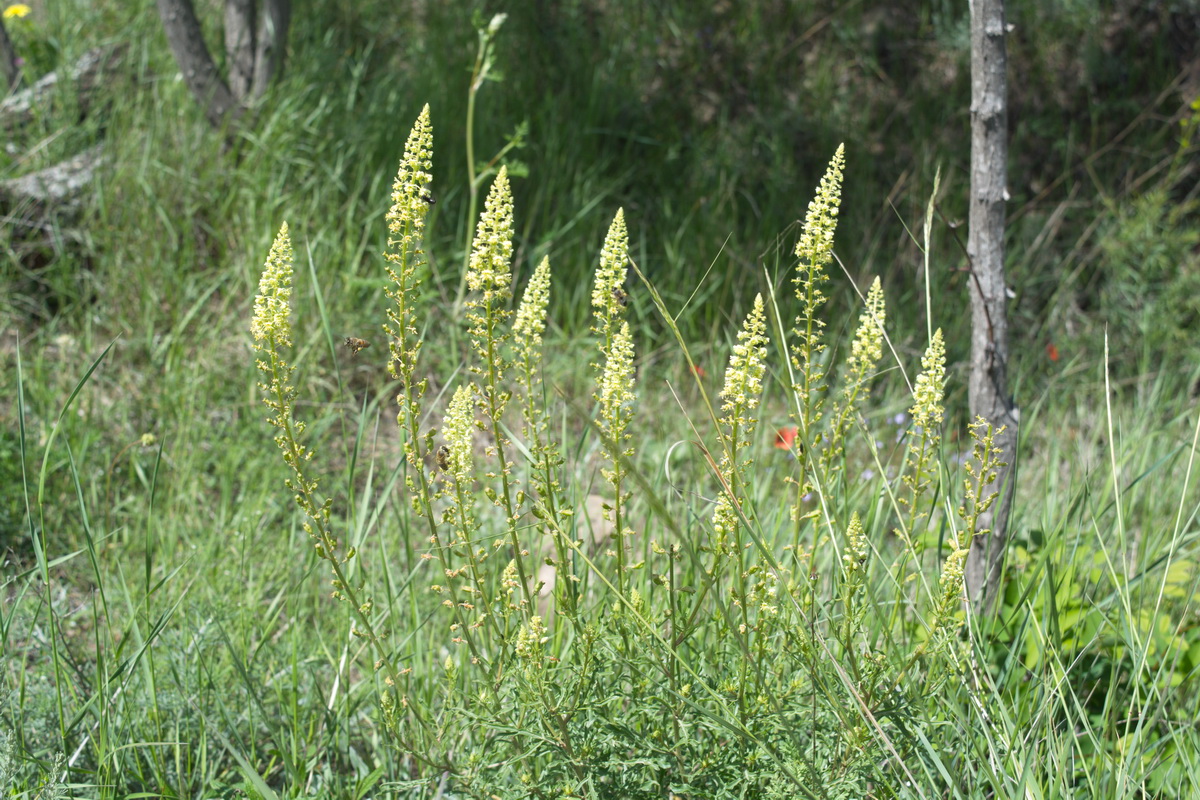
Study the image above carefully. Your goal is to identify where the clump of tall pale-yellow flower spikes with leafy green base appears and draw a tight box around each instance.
[252,108,997,799]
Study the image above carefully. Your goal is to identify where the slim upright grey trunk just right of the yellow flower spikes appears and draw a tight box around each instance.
[965,0,1019,613]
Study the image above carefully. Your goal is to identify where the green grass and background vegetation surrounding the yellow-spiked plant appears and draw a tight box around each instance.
[0,0,1200,798]
